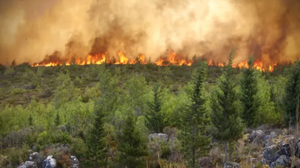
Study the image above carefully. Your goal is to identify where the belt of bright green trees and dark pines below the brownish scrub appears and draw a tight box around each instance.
[0,52,300,168]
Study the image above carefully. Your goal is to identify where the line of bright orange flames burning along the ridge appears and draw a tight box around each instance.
[32,51,277,72]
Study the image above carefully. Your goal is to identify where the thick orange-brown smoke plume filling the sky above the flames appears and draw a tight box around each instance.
[0,0,300,65]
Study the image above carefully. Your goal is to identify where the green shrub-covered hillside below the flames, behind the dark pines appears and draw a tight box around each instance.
[0,64,294,167]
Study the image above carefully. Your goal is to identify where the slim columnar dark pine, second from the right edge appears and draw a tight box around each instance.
[241,56,260,127]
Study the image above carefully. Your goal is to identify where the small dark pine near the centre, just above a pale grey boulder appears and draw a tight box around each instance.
[145,85,167,133]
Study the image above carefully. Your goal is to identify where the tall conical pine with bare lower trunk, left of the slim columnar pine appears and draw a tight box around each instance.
[211,51,244,163]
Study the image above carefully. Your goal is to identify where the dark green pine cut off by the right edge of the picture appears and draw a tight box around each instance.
[284,61,300,126]
